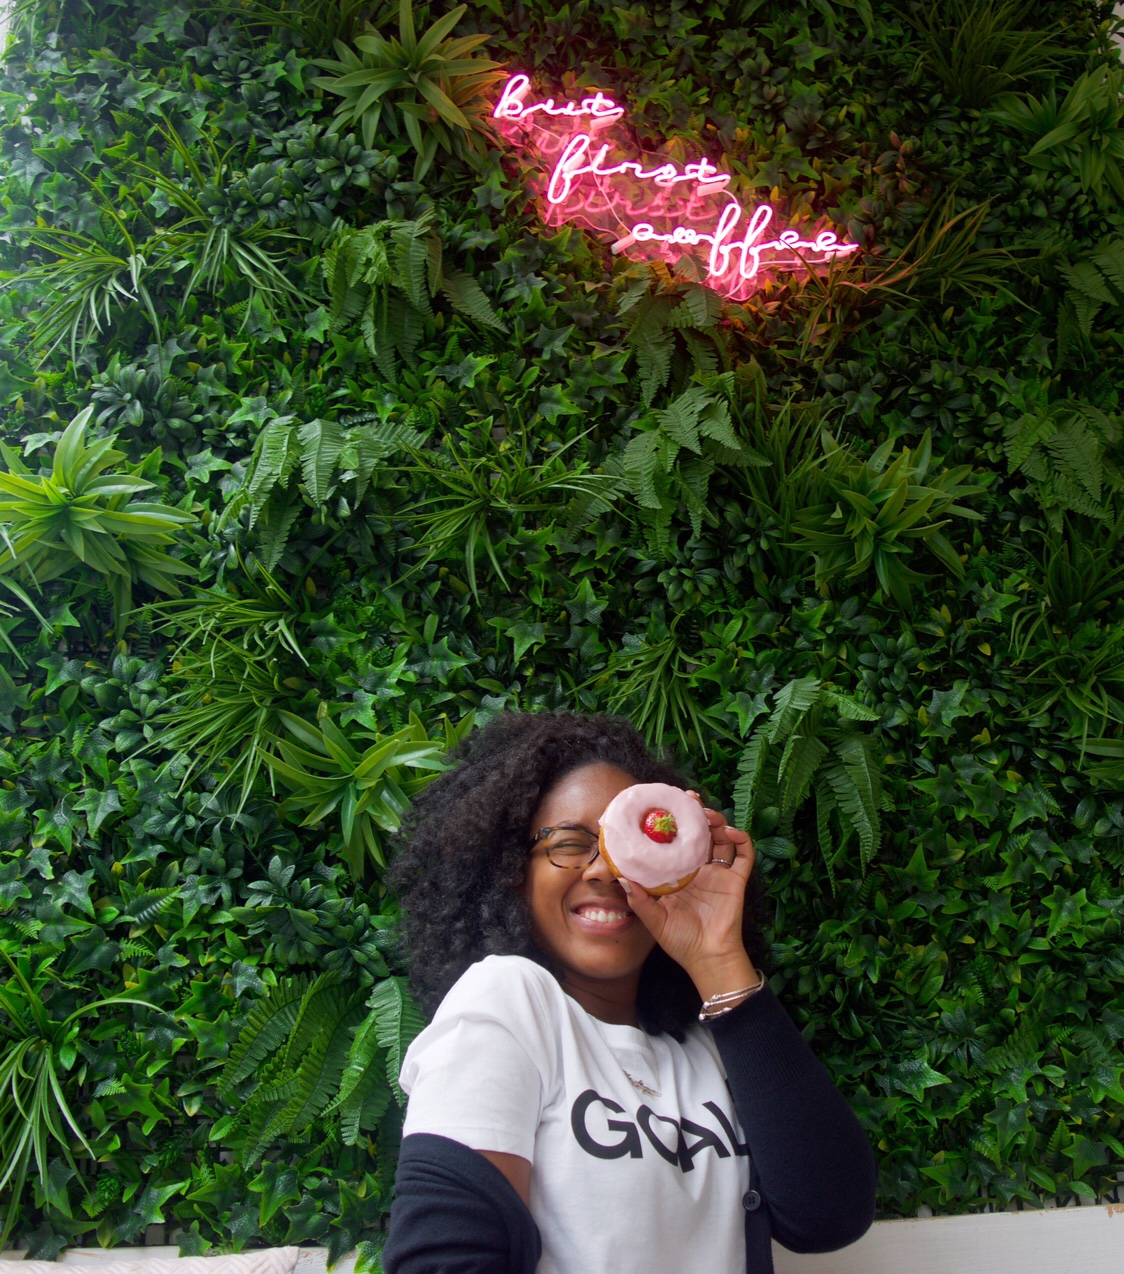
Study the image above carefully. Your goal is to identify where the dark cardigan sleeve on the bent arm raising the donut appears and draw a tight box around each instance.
[710,986,878,1252]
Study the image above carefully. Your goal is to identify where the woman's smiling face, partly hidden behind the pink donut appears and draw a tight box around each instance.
[524,762,655,1023]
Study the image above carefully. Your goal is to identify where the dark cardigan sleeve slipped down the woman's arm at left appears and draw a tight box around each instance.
[382,1133,543,1274]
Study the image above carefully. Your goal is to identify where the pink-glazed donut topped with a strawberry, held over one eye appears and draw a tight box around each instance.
[599,784,710,893]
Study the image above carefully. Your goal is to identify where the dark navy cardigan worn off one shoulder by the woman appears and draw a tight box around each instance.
[382,987,878,1274]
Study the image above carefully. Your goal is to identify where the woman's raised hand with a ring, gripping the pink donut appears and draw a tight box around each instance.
[622,792,757,1000]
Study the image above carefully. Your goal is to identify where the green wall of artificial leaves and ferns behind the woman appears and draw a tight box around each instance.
[0,0,1124,1263]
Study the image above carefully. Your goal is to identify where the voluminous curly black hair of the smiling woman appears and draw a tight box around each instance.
[389,712,763,1037]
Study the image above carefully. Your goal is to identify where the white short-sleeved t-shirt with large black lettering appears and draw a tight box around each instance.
[401,956,749,1274]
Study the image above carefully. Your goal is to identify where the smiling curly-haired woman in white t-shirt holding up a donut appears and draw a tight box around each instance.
[382,712,875,1274]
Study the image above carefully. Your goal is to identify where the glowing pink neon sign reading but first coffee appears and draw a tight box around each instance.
[492,75,859,299]
